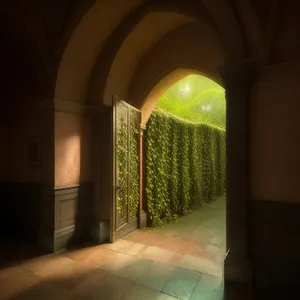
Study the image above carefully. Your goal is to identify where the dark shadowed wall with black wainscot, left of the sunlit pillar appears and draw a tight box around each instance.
[0,105,47,243]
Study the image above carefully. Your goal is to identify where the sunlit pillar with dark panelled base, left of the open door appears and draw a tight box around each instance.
[39,99,93,252]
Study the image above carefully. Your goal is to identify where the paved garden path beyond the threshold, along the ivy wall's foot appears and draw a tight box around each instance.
[126,197,226,258]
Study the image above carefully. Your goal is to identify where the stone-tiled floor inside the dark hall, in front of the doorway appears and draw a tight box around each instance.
[0,241,222,300]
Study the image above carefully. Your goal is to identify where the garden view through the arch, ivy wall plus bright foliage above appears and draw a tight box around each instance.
[144,75,226,227]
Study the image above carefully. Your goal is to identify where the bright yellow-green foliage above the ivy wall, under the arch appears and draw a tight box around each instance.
[157,75,226,128]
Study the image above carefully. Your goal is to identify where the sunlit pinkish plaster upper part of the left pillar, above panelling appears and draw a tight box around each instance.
[54,111,92,187]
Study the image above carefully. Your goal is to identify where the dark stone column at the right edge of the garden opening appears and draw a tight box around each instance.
[220,61,254,287]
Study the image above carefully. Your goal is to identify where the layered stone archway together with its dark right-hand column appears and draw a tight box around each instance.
[55,1,252,292]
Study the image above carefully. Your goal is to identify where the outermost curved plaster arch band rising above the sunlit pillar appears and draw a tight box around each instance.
[55,0,140,102]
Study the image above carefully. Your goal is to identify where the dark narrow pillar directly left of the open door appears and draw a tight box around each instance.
[90,105,114,244]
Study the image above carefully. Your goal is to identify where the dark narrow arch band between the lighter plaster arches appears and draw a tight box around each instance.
[89,0,223,104]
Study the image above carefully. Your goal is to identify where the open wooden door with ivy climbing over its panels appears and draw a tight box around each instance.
[111,96,141,242]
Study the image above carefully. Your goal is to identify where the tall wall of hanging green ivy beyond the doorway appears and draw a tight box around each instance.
[145,109,226,227]
